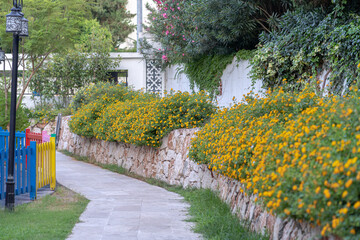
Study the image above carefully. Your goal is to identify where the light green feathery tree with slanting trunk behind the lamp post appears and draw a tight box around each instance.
[0,0,90,111]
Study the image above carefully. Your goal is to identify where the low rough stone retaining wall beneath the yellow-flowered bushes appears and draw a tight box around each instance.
[58,117,320,240]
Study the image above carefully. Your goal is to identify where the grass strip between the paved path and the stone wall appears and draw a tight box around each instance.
[61,151,269,240]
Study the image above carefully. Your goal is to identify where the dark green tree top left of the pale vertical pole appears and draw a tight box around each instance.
[92,0,135,47]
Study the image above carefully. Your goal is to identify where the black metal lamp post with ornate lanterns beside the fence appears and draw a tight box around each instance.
[5,0,28,211]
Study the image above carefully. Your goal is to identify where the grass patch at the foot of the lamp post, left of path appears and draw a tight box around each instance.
[0,186,89,240]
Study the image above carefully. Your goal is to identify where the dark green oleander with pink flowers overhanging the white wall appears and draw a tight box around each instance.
[143,0,291,63]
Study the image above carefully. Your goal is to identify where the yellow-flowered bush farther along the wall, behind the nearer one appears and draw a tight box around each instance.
[69,87,215,147]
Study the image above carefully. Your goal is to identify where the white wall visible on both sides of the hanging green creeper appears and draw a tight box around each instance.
[165,58,261,107]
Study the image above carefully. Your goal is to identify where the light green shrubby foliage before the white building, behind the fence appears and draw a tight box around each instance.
[30,20,120,107]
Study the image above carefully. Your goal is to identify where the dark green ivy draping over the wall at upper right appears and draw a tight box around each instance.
[251,2,360,94]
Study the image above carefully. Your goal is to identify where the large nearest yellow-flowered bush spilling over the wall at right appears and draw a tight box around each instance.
[189,84,360,239]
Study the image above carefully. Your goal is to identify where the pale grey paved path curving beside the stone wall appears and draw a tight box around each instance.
[56,152,201,240]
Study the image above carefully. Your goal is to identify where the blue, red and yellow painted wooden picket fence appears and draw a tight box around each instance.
[0,128,56,200]
